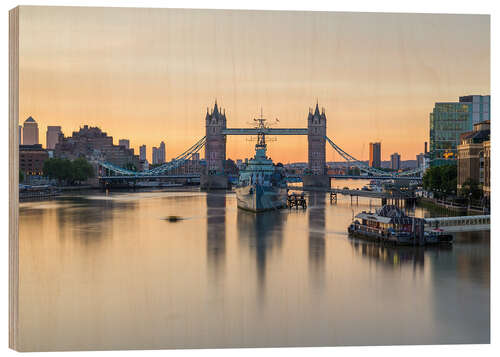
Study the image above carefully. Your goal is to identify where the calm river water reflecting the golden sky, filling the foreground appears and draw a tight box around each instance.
[19,181,490,350]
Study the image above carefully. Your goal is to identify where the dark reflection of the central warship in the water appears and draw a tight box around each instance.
[237,210,286,301]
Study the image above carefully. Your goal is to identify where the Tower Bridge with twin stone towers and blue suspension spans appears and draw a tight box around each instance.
[99,101,421,189]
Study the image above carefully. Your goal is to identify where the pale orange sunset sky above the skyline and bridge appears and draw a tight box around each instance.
[19,7,490,163]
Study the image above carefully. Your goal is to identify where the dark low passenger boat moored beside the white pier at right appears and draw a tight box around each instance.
[347,205,426,245]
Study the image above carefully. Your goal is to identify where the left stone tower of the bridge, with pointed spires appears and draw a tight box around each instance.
[200,100,228,190]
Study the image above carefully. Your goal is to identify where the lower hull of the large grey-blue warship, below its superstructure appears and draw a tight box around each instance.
[235,185,287,212]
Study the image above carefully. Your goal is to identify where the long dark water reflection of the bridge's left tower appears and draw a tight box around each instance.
[206,193,226,280]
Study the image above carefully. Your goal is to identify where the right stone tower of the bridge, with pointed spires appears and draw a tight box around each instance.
[302,102,330,188]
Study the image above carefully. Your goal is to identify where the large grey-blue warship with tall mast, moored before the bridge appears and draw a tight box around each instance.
[235,114,288,212]
